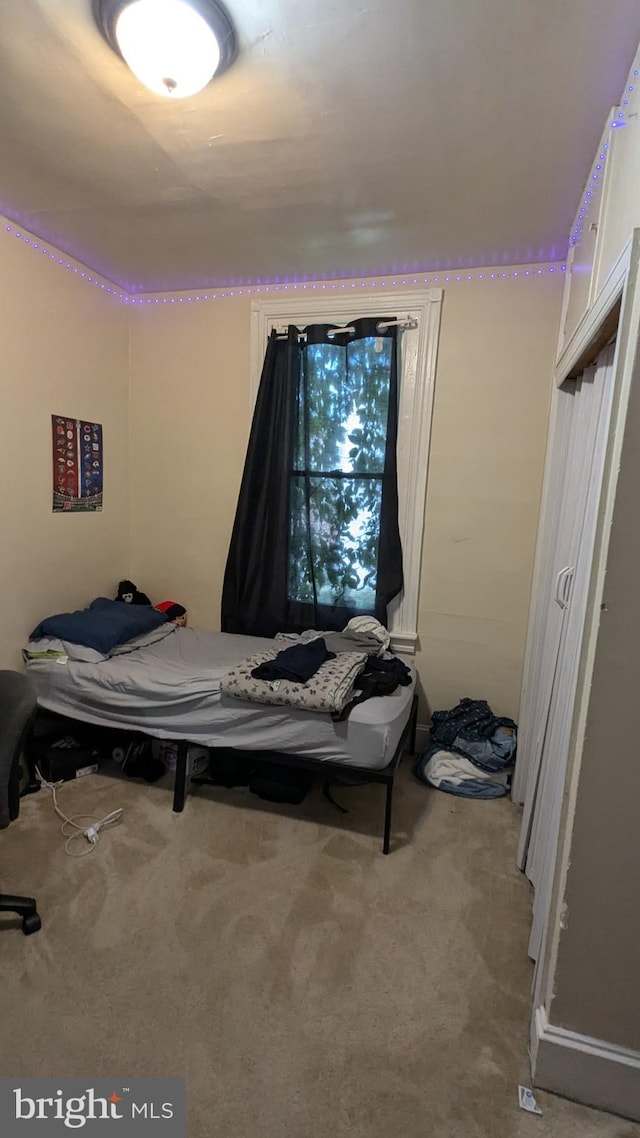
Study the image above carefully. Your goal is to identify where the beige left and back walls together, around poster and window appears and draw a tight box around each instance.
[0,228,560,721]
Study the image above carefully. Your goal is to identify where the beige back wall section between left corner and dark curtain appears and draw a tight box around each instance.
[131,297,251,629]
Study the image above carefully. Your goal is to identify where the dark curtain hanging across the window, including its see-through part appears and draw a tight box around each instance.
[221,318,402,636]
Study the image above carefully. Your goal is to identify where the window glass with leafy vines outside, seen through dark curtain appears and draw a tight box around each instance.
[288,336,392,611]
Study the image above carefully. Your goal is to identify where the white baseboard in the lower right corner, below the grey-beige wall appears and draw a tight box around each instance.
[531,1007,640,1122]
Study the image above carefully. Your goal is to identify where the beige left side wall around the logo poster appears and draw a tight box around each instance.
[0,215,129,667]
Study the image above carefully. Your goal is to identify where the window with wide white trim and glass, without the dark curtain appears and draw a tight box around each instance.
[252,286,442,652]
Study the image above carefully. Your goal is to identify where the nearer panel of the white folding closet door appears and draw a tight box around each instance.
[525,346,615,959]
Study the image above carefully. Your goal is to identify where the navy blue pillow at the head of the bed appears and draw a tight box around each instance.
[30,596,166,655]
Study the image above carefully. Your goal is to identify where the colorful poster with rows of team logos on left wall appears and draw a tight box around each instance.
[51,415,102,513]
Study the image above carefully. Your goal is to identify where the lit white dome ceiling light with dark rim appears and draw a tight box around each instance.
[93,0,236,99]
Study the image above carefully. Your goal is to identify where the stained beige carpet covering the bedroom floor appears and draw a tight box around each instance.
[0,762,640,1138]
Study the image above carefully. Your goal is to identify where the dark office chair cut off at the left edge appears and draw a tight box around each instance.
[0,670,41,937]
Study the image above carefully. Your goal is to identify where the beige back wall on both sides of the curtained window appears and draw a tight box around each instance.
[131,273,561,721]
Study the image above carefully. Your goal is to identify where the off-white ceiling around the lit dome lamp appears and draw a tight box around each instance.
[0,0,640,292]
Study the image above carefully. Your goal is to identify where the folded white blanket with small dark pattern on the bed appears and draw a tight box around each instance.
[220,651,368,712]
